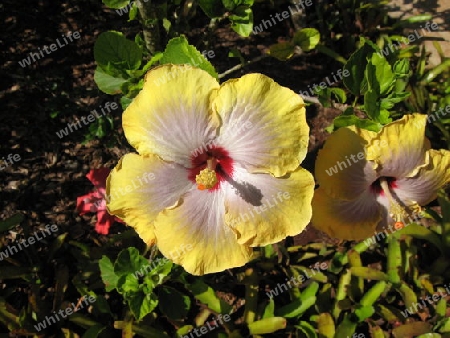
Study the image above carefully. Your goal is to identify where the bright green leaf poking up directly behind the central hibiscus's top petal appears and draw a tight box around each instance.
[160,35,218,79]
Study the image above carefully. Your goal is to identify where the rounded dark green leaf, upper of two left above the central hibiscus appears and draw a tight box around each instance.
[94,31,142,69]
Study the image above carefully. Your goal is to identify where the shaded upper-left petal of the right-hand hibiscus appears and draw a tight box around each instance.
[315,128,377,200]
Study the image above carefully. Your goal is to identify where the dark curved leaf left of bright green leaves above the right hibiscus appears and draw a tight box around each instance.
[343,44,375,96]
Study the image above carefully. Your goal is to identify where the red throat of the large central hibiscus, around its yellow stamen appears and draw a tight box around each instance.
[188,146,233,190]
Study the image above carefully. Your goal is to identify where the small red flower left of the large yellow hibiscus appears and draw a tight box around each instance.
[77,168,123,235]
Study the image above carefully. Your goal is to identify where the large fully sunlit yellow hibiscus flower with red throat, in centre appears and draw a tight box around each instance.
[107,65,314,275]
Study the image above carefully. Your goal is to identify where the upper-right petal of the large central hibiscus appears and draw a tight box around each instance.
[213,74,309,177]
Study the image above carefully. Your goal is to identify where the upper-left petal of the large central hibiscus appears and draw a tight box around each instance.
[123,65,219,167]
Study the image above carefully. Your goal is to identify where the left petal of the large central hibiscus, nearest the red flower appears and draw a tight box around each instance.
[107,153,194,244]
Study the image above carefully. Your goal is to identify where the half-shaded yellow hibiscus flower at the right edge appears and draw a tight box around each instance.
[311,114,450,240]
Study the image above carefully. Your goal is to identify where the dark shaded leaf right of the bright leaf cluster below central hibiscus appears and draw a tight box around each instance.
[158,286,191,320]
